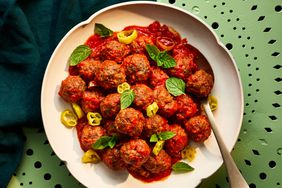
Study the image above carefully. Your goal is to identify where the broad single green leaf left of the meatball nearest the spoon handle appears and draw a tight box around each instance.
[165,77,185,96]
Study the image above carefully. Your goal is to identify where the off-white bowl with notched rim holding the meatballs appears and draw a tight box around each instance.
[41,1,243,188]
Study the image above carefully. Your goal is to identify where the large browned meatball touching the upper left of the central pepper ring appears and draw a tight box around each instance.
[96,60,126,89]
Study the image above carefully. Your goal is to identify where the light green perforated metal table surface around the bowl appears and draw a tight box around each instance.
[8,0,282,188]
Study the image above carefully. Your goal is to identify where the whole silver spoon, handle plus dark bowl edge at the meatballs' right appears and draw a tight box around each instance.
[192,46,249,188]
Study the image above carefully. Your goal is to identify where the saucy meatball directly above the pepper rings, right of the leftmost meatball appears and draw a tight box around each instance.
[81,90,104,113]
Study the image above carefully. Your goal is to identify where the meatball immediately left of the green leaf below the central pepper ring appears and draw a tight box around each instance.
[100,93,120,118]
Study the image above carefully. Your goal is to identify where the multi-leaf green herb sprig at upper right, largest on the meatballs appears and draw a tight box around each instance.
[146,44,176,69]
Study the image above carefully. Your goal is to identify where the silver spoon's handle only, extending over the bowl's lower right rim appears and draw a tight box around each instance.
[202,100,249,188]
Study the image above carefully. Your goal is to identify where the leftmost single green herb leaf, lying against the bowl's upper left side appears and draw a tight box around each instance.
[69,45,92,66]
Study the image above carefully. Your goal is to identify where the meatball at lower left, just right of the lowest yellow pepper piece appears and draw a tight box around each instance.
[102,148,125,170]
